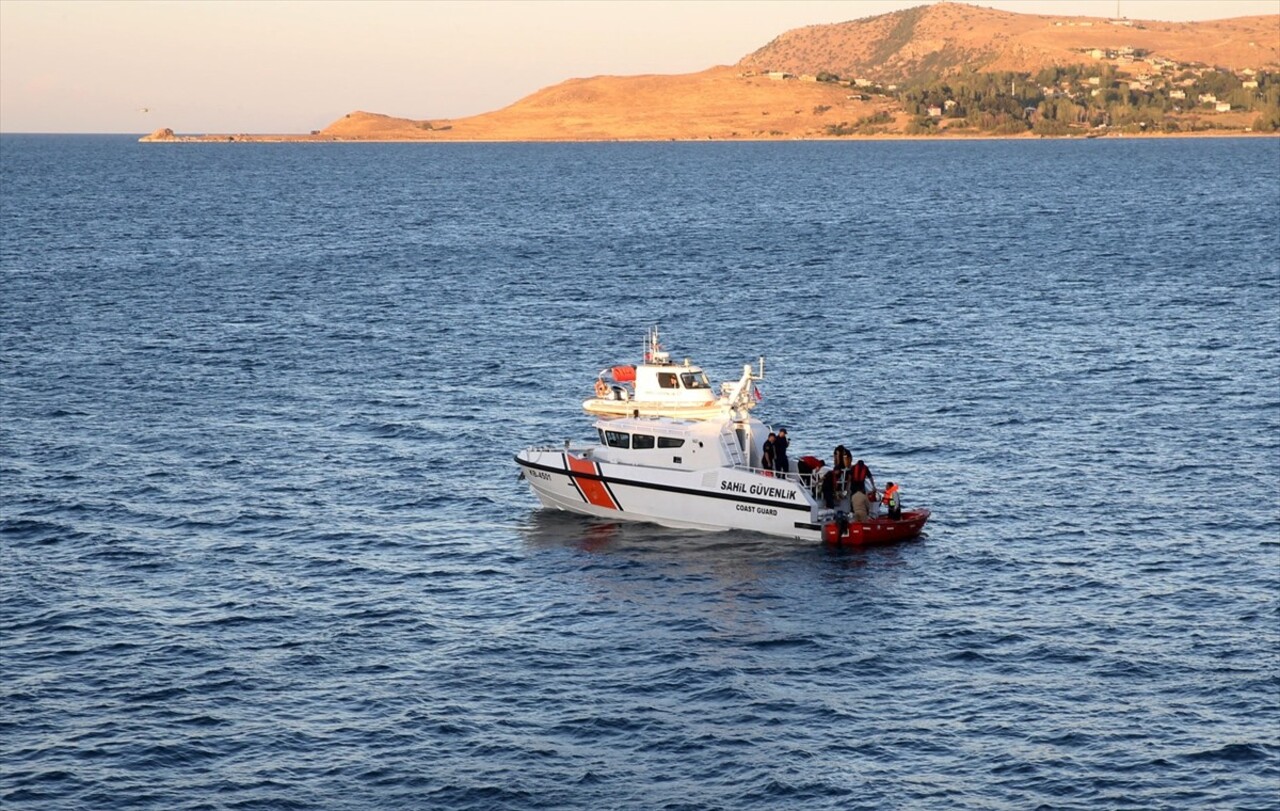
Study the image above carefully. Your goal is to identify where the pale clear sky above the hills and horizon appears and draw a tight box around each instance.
[0,0,1280,133]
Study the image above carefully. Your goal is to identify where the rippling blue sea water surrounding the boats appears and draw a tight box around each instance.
[0,136,1280,810]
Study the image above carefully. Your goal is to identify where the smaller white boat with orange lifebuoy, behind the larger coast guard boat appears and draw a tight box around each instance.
[582,327,764,420]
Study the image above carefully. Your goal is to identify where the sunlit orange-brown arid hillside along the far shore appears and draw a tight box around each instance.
[143,3,1280,141]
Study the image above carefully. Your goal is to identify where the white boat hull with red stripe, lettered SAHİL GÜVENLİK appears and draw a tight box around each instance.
[516,449,822,541]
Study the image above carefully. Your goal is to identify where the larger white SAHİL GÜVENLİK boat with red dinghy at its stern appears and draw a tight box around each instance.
[516,367,929,544]
